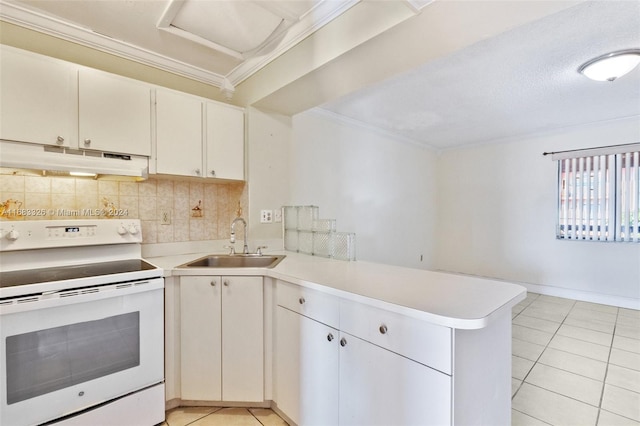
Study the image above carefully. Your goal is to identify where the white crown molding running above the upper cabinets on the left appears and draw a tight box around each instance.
[0,1,224,87]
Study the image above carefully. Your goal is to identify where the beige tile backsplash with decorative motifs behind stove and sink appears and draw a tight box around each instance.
[0,174,248,243]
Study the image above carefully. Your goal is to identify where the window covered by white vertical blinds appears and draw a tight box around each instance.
[553,144,640,243]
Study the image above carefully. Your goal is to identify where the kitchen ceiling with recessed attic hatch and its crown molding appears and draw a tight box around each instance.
[0,0,424,98]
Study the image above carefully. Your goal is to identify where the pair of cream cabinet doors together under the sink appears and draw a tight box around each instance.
[180,276,264,402]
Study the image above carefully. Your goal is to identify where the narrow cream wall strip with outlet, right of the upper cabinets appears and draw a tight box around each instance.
[247,108,291,245]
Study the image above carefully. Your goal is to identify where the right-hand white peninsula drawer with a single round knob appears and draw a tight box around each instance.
[340,300,452,374]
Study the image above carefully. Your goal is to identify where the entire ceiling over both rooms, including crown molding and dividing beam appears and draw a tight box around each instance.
[0,0,640,149]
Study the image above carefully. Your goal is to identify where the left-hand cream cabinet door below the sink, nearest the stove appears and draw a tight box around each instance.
[180,277,222,401]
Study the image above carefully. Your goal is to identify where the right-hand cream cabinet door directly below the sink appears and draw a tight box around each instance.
[222,277,264,402]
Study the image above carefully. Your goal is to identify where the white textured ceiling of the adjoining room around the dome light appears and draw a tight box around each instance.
[322,1,640,149]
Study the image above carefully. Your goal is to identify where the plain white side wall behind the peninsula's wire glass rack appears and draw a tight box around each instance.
[289,110,436,268]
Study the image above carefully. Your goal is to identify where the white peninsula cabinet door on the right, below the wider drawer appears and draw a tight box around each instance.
[340,333,451,426]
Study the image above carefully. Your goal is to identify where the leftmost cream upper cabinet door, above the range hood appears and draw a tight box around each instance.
[0,46,78,148]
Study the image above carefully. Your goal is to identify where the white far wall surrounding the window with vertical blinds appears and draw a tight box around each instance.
[436,117,640,308]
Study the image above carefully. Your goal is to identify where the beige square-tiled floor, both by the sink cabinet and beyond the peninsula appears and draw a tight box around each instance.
[164,293,640,426]
